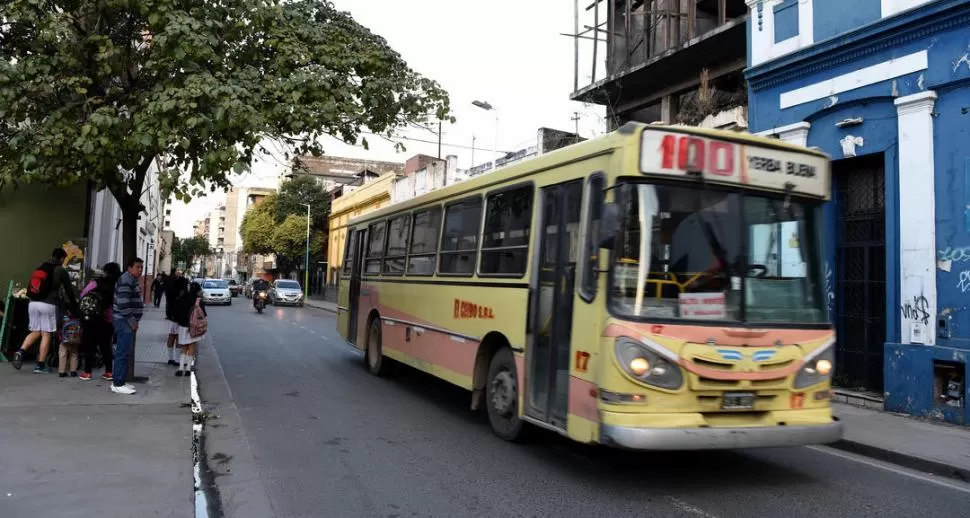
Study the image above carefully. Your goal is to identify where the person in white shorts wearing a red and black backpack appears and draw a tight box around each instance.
[12,248,77,374]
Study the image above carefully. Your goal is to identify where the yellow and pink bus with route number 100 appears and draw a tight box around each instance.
[337,123,842,450]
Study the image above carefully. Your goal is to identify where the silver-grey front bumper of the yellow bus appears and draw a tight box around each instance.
[600,417,842,450]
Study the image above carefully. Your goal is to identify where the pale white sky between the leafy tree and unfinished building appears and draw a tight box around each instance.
[172,0,606,236]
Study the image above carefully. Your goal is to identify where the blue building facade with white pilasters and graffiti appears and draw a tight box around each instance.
[745,0,970,425]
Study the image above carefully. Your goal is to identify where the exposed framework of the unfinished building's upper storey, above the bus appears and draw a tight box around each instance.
[564,0,747,91]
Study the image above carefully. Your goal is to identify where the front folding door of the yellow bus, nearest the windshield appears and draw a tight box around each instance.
[526,180,583,430]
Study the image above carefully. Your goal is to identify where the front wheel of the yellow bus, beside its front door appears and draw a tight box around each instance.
[485,347,527,442]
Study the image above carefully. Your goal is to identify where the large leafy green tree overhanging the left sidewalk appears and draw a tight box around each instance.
[0,0,451,264]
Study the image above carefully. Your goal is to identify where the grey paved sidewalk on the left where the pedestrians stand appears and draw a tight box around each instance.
[0,308,195,518]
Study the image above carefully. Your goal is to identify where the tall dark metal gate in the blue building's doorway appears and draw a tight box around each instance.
[832,154,886,392]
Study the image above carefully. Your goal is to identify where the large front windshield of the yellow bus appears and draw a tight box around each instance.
[610,182,828,324]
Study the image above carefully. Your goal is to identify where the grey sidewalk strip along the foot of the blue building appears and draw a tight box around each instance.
[831,403,970,482]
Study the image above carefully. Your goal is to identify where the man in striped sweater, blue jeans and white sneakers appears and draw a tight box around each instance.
[111,257,145,394]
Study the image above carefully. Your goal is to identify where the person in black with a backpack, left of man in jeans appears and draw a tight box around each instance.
[78,263,121,381]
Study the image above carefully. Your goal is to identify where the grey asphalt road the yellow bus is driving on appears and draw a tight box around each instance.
[200,299,970,518]
